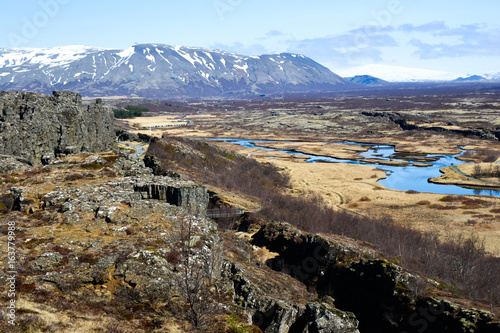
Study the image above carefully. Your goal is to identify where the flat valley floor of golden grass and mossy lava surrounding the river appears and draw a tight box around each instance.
[116,92,500,254]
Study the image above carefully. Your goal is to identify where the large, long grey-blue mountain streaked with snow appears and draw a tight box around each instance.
[0,44,347,98]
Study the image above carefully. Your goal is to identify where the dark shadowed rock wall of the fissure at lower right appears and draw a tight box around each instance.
[253,222,498,333]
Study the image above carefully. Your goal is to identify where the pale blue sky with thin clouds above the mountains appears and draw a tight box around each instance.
[0,0,500,75]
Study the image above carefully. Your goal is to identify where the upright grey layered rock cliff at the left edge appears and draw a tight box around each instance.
[0,91,115,164]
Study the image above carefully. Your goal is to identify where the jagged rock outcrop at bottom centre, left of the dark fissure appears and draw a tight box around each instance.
[223,262,359,333]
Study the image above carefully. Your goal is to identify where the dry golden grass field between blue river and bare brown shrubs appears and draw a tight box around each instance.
[266,159,500,254]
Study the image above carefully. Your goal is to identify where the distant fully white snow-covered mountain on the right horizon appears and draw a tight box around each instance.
[338,64,460,82]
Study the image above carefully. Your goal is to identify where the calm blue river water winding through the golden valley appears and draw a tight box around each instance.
[212,139,500,196]
